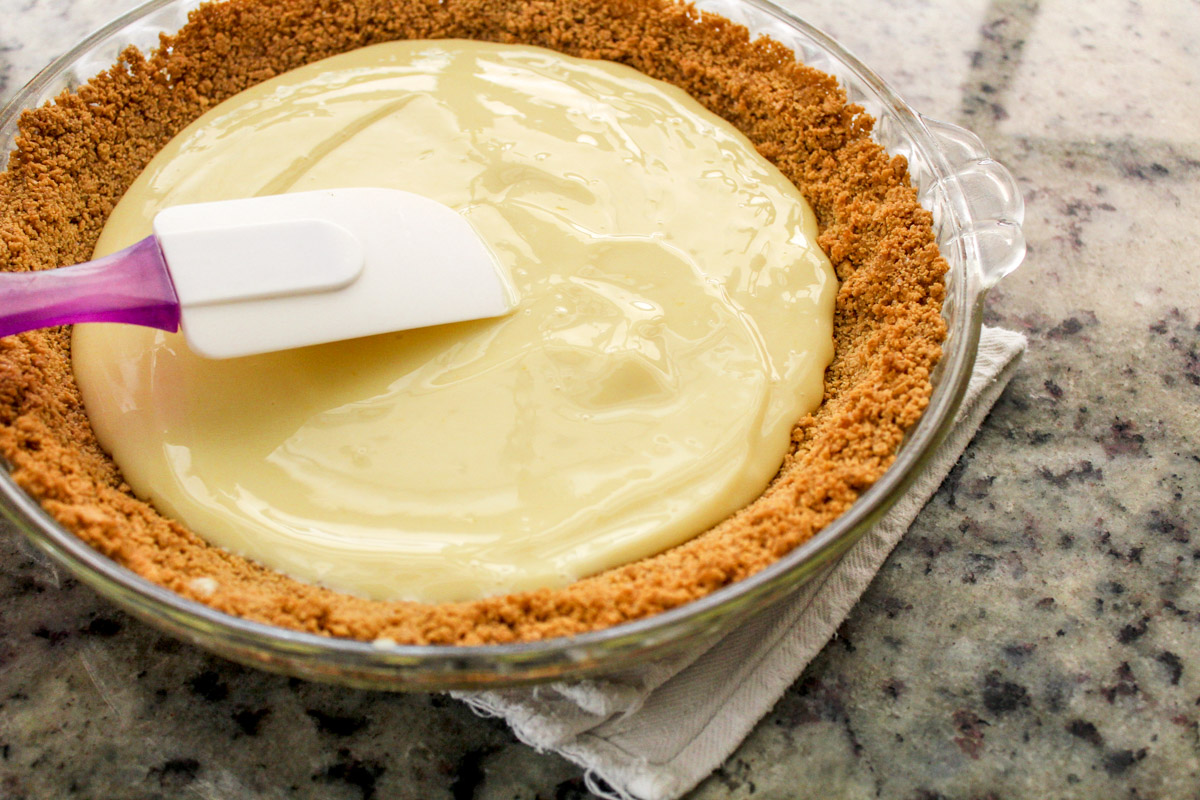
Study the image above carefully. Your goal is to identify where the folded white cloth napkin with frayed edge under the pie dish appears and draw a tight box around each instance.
[455,327,1026,800]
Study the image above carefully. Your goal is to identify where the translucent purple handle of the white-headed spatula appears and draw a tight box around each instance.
[0,236,179,336]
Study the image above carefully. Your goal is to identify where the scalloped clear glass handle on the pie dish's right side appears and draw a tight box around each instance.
[922,116,1025,289]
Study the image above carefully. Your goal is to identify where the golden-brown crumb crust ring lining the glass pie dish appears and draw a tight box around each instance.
[0,0,946,644]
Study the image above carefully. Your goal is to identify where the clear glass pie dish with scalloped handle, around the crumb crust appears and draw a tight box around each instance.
[0,0,1024,690]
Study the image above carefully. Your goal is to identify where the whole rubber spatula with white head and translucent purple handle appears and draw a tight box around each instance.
[0,188,516,359]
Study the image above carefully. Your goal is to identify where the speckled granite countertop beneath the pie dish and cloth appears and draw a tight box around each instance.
[0,0,1200,800]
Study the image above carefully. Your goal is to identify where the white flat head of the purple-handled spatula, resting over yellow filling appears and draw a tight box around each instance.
[154,188,516,359]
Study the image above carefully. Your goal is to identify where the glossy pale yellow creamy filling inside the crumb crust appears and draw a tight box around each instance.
[73,41,836,601]
